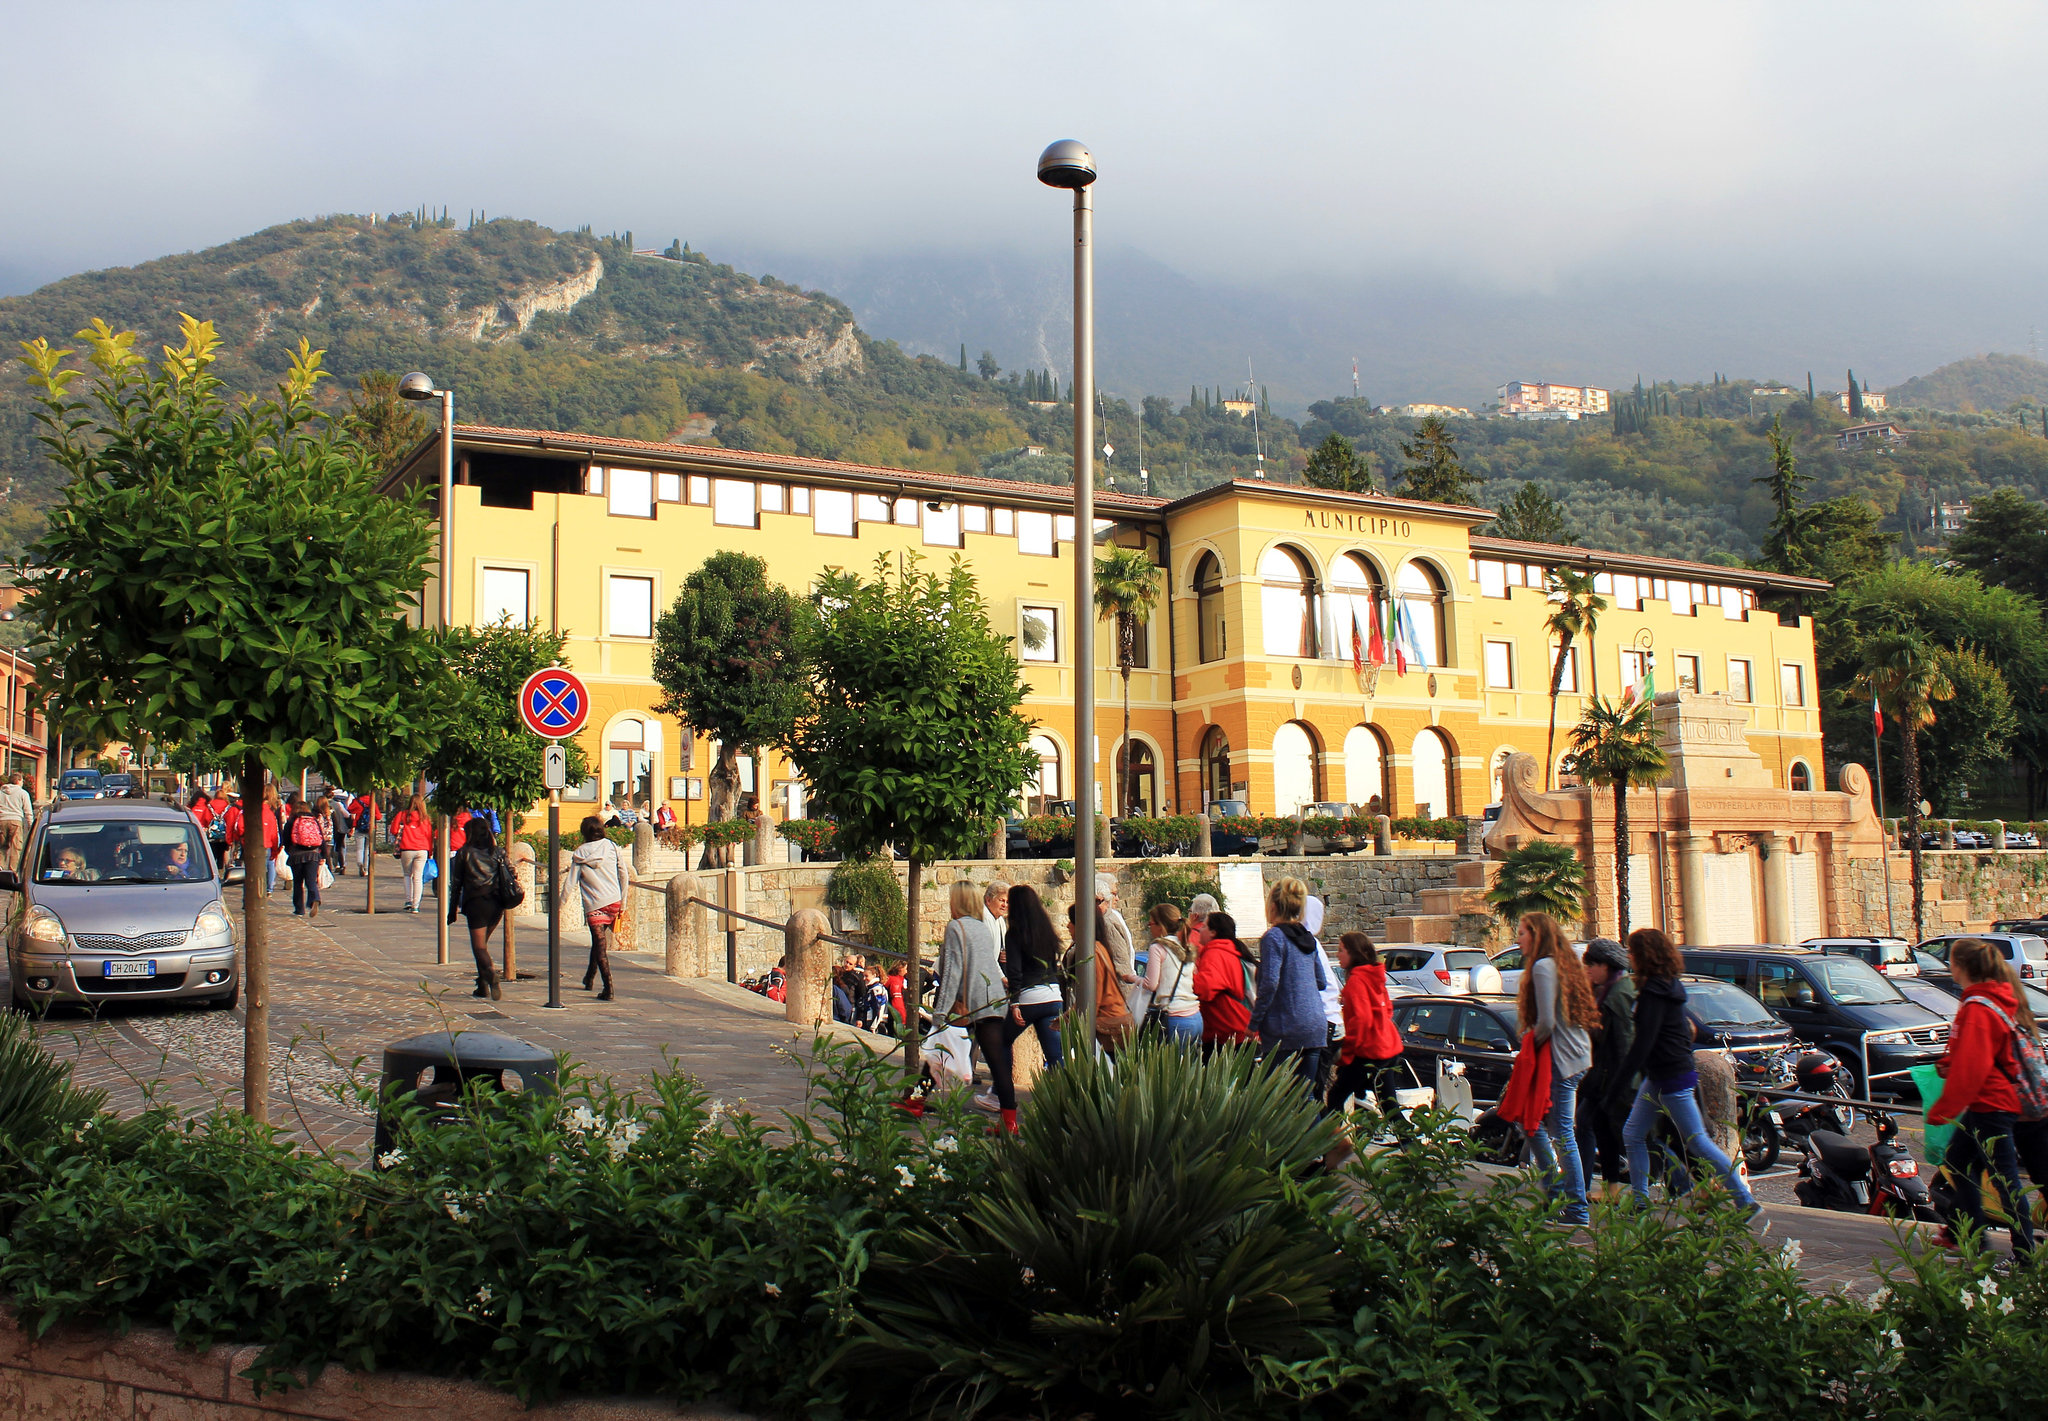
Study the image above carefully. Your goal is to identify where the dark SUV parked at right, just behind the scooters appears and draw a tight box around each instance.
[1686,946,1948,1100]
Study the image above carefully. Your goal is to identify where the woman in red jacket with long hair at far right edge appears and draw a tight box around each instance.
[1927,938,2034,1253]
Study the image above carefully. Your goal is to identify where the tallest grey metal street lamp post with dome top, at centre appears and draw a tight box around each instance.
[1038,137,1096,1050]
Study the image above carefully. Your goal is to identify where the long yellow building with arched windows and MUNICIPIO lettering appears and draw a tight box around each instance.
[385,426,1827,819]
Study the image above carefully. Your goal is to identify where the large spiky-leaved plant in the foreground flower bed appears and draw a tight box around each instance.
[827,1042,1339,1417]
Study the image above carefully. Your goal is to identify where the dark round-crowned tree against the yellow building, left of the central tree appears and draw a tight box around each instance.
[653,553,811,862]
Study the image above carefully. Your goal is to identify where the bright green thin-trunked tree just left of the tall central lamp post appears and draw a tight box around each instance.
[788,555,1036,1075]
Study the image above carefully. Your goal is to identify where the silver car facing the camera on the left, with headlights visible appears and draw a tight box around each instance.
[0,799,242,1009]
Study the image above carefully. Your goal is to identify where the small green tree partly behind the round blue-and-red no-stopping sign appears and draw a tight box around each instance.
[424,618,590,833]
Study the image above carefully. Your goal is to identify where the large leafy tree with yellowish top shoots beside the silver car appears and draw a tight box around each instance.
[23,315,446,1120]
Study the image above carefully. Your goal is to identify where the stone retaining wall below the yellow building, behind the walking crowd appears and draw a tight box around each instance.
[700,854,1460,977]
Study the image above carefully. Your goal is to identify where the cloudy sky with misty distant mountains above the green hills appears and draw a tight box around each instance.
[0,0,2048,397]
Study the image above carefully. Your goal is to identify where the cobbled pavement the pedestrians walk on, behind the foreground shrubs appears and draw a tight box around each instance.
[4,874,2003,1292]
